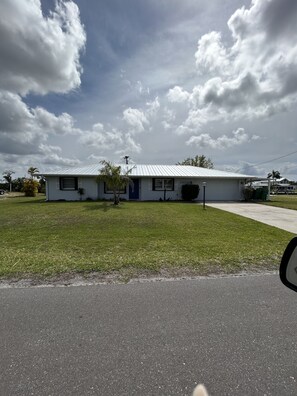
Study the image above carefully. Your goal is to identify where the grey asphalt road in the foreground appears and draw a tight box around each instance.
[0,275,297,396]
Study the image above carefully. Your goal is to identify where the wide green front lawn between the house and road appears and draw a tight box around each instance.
[0,197,292,278]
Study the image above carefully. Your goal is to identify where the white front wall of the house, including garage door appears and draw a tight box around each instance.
[46,176,244,202]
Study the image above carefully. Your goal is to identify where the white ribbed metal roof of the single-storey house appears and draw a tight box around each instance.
[40,164,257,179]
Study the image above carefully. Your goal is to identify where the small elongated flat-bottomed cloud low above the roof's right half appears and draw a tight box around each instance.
[186,128,259,150]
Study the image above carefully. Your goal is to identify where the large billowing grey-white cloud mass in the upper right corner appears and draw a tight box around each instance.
[167,0,297,134]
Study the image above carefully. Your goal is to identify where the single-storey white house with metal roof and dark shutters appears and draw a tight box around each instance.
[42,164,257,201]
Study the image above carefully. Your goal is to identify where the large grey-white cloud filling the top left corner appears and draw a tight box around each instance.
[0,0,86,95]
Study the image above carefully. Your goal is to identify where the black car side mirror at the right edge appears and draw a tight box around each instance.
[279,237,297,292]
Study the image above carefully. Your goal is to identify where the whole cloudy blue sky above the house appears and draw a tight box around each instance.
[0,0,297,180]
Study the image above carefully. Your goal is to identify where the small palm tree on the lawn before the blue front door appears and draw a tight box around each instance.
[97,160,132,205]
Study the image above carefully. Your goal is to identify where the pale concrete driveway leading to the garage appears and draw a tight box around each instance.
[207,202,297,234]
